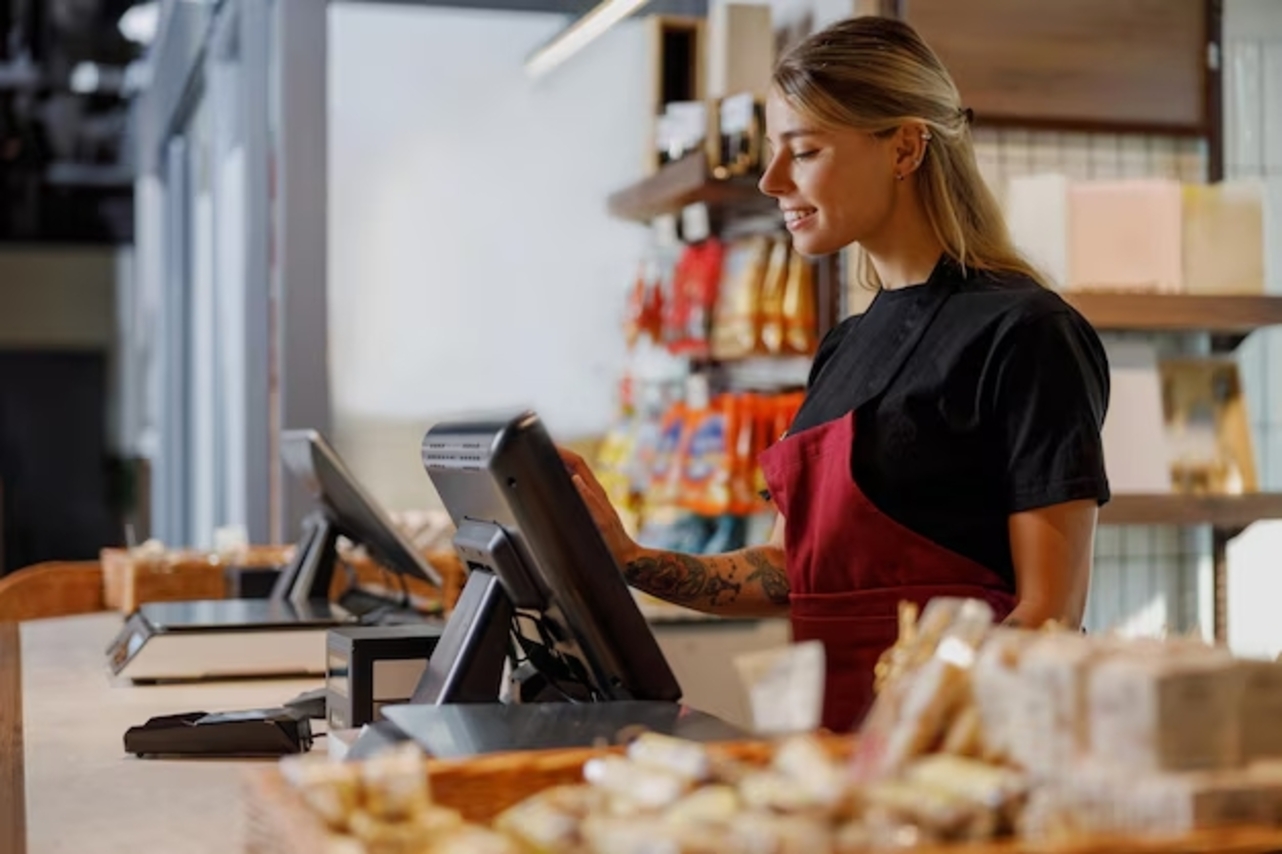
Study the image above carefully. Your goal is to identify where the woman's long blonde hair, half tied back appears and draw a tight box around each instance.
[774,17,1045,287]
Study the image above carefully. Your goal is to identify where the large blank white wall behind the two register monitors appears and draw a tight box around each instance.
[329,3,649,505]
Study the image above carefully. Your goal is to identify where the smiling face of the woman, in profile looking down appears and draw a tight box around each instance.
[758,92,900,255]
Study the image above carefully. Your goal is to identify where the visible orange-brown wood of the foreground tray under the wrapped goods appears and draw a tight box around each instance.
[244,736,1282,854]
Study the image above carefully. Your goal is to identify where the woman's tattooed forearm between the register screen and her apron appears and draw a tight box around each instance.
[623,549,788,614]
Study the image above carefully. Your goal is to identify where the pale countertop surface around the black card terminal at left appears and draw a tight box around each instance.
[0,614,326,854]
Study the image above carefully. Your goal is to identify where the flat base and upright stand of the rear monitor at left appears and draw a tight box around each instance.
[106,512,358,682]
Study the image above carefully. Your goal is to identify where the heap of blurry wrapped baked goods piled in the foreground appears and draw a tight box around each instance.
[275,599,1282,854]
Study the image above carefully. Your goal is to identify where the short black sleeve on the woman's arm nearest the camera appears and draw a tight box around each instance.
[990,310,1110,513]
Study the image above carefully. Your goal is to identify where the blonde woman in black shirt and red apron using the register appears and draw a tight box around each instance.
[567,17,1109,731]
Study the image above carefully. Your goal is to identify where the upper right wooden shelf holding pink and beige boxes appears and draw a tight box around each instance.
[1060,291,1282,335]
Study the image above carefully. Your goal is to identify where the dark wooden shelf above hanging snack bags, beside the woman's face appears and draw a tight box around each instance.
[608,154,778,222]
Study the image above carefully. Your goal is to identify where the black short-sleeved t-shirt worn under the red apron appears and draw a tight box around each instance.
[790,252,1109,585]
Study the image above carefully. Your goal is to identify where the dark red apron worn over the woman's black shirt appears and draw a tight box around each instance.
[760,275,1015,732]
